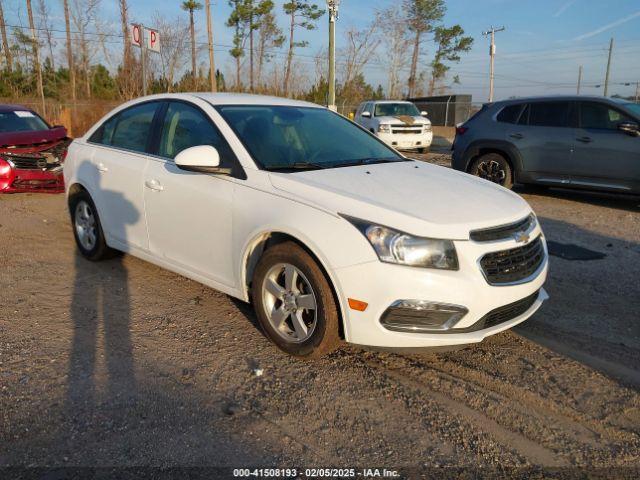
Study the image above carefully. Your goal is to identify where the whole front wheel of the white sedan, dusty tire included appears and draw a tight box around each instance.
[252,242,340,359]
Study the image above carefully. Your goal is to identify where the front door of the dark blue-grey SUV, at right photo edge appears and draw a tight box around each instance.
[571,101,640,190]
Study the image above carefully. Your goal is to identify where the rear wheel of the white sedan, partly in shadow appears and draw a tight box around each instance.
[69,190,116,262]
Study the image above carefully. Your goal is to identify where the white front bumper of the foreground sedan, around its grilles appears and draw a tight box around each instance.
[334,226,548,348]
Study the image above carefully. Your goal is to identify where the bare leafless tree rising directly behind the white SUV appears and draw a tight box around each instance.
[380,5,409,98]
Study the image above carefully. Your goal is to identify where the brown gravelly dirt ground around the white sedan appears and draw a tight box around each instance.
[0,155,640,478]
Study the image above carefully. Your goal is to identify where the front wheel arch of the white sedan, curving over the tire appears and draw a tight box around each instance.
[241,229,346,339]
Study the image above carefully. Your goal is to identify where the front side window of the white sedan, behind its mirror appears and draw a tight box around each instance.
[158,102,230,160]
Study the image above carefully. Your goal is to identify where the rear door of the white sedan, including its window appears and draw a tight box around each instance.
[87,102,161,251]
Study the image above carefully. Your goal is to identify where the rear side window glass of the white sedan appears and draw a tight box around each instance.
[89,102,160,152]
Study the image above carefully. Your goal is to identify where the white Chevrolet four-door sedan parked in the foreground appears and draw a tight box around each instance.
[64,93,548,358]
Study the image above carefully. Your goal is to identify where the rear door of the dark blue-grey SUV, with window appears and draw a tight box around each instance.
[505,100,575,183]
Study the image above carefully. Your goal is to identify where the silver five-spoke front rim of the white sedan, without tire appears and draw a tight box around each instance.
[261,263,318,343]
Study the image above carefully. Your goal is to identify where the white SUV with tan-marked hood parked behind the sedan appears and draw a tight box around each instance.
[354,100,433,153]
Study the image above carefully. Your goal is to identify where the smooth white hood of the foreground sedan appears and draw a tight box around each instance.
[269,161,531,240]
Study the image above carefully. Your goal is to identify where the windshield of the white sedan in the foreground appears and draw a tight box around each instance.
[217,105,404,170]
